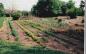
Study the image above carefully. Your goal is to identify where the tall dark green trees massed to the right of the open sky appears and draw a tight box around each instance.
[32,0,84,17]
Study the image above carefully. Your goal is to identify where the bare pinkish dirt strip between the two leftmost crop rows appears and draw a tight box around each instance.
[13,21,38,46]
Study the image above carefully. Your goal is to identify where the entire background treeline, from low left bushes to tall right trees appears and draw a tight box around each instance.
[0,0,85,20]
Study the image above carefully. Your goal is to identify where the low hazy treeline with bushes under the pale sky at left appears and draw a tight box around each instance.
[0,3,31,20]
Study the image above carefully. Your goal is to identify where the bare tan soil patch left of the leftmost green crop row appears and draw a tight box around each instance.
[0,20,15,41]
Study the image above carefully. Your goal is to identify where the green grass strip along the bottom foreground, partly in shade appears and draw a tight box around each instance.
[0,40,65,54]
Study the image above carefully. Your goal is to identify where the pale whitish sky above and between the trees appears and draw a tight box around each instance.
[0,0,81,11]
